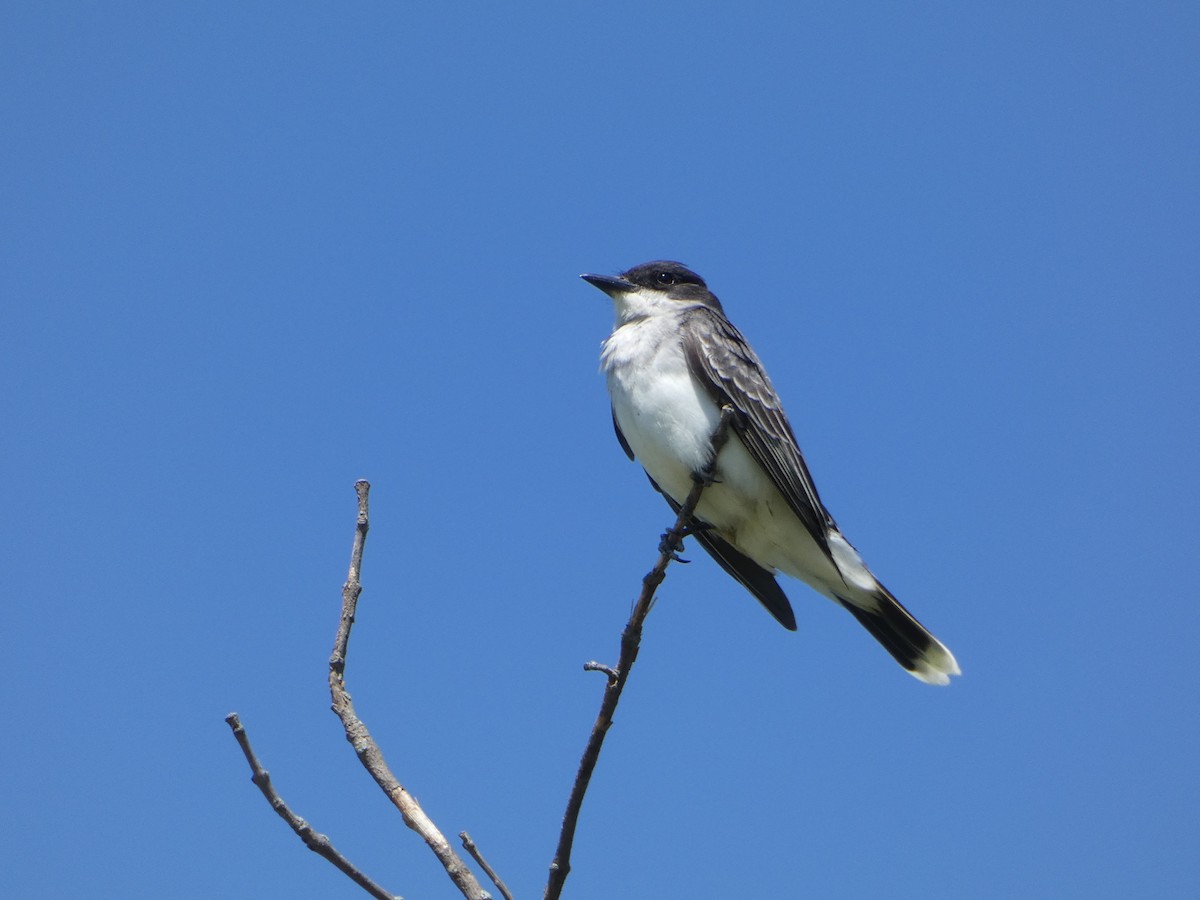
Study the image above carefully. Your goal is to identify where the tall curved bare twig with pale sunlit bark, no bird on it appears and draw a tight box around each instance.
[329,481,491,900]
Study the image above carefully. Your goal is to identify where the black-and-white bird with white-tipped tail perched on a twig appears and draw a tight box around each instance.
[580,259,961,685]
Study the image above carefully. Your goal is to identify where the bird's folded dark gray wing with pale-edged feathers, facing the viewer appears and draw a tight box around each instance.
[680,307,838,553]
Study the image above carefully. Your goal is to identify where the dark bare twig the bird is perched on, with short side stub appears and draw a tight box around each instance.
[542,406,734,900]
